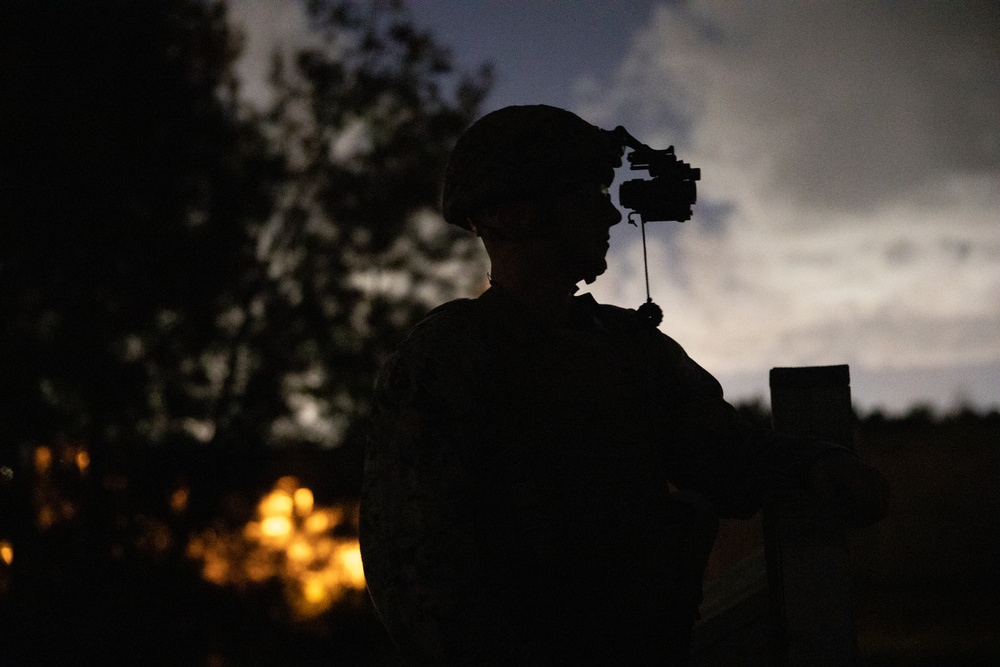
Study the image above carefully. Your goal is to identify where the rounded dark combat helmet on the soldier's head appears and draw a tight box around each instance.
[441,104,622,229]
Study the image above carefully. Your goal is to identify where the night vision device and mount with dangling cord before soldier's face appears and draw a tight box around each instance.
[603,125,701,327]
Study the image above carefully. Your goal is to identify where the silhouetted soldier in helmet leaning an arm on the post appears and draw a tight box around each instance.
[361,106,884,665]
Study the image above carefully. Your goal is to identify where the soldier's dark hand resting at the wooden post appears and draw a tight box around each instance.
[809,452,889,528]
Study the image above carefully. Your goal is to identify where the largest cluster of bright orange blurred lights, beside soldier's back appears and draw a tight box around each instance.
[187,477,365,619]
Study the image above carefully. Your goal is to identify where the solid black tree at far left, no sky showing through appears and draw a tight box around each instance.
[0,0,277,460]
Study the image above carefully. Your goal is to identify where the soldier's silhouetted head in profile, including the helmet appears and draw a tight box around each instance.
[442,105,622,282]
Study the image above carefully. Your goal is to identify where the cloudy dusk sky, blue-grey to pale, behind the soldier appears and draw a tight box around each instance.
[232,0,1000,413]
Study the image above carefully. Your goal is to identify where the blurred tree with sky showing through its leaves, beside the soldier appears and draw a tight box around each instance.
[211,2,489,460]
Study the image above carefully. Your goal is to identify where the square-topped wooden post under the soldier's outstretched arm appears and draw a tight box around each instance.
[764,365,857,667]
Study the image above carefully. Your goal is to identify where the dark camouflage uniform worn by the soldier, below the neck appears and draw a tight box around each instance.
[361,287,834,665]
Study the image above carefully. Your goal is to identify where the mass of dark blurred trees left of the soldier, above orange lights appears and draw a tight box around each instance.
[0,0,489,470]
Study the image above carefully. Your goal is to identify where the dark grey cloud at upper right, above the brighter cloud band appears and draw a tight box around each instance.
[581,0,1000,211]
